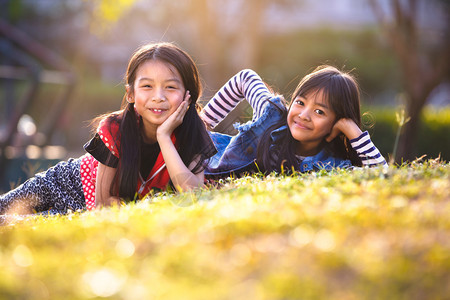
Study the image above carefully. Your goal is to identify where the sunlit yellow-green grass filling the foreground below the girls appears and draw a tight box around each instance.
[0,160,450,299]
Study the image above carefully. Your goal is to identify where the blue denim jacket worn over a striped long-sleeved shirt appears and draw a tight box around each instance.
[205,97,352,177]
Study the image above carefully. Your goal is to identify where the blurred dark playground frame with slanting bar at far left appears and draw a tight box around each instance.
[0,19,76,191]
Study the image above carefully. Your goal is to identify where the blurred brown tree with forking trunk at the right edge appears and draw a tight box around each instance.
[370,0,450,160]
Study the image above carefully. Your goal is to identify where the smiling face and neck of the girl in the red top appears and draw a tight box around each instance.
[128,60,186,142]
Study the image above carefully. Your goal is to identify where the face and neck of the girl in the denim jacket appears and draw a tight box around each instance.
[287,91,336,156]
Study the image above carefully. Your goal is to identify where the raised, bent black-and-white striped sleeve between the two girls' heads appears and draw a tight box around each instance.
[200,69,273,128]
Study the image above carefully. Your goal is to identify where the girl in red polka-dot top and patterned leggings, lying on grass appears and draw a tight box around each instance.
[0,43,216,214]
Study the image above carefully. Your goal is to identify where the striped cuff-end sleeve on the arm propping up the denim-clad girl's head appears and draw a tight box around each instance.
[350,131,387,167]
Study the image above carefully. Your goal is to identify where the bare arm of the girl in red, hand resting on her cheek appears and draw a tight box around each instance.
[156,93,204,192]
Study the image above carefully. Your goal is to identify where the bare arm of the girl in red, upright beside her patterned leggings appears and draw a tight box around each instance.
[95,163,120,208]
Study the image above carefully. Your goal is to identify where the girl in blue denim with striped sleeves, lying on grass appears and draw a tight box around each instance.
[200,66,387,178]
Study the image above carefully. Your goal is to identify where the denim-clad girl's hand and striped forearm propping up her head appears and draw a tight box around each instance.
[326,118,387,166]
